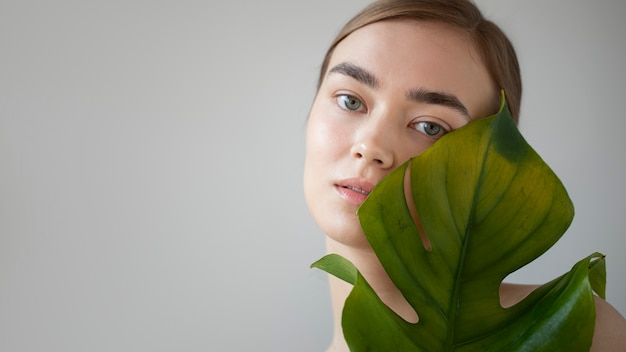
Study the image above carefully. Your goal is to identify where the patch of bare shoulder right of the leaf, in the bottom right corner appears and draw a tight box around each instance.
[591,297,626,352]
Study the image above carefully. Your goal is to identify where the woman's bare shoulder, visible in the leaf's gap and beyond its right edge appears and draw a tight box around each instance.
[500,283,626,352]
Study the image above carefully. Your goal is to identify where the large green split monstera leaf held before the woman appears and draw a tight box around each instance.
[313,94,605,352]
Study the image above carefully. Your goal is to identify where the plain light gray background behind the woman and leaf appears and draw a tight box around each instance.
[0,0,626,351]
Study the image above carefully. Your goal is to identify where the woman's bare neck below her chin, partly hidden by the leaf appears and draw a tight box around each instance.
[326,237,418,352]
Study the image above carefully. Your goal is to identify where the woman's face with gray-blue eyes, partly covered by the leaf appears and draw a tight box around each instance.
[304,21,499,248]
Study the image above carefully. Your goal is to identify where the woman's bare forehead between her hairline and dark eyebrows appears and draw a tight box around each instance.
[327,20,499,117]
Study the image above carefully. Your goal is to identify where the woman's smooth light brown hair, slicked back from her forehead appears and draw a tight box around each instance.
[318,0,522,123]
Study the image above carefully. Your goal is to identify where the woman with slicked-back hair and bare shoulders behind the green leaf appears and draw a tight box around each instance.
[304,0,626,351]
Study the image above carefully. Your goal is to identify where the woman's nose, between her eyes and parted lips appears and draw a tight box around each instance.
[351,126,394,169]
